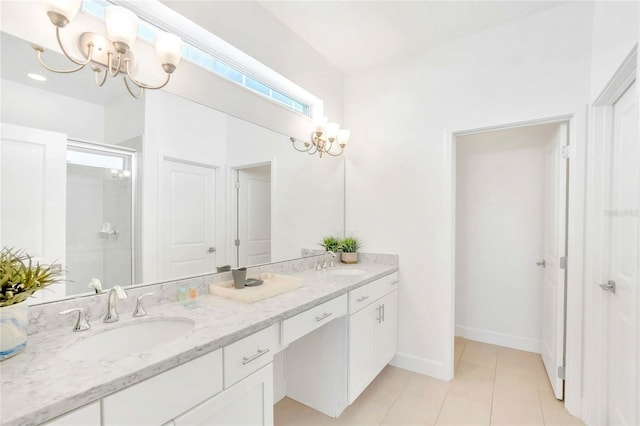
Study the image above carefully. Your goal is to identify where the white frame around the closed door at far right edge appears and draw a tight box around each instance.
[583,45,640,424]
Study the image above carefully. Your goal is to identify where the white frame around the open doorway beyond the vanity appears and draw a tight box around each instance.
[442,109,587,416]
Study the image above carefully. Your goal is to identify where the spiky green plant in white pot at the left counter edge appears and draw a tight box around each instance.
[0,247,61,361]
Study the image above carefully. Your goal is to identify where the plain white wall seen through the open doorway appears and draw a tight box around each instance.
[455,124,558,352]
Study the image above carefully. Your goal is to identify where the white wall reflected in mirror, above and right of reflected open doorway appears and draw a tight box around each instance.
[227,113,344,261]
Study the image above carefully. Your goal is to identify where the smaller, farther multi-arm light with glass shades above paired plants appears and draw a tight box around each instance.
[289,117,351,158]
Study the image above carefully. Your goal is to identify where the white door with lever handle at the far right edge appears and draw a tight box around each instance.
[601,83,640,425]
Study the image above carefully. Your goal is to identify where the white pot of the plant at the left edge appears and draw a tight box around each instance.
[0,302,29,361]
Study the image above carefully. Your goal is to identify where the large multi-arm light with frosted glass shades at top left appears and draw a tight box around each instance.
[33,0,182,99]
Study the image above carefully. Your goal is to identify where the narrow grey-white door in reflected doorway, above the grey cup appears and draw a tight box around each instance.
[236,163,271,266]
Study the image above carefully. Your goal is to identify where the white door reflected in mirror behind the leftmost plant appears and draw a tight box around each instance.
[0,124,67,303]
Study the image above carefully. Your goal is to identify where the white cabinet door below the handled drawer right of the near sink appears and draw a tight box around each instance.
[174,364,273,426]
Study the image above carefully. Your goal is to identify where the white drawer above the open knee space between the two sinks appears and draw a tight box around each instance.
[282,294,347,346]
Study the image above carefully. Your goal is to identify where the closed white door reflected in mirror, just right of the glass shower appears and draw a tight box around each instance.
[160,158,216,279]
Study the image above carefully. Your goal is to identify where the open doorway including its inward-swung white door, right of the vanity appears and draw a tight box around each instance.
[454,120,569,399]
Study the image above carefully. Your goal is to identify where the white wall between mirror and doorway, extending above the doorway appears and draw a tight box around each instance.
[345,2,593,379]
